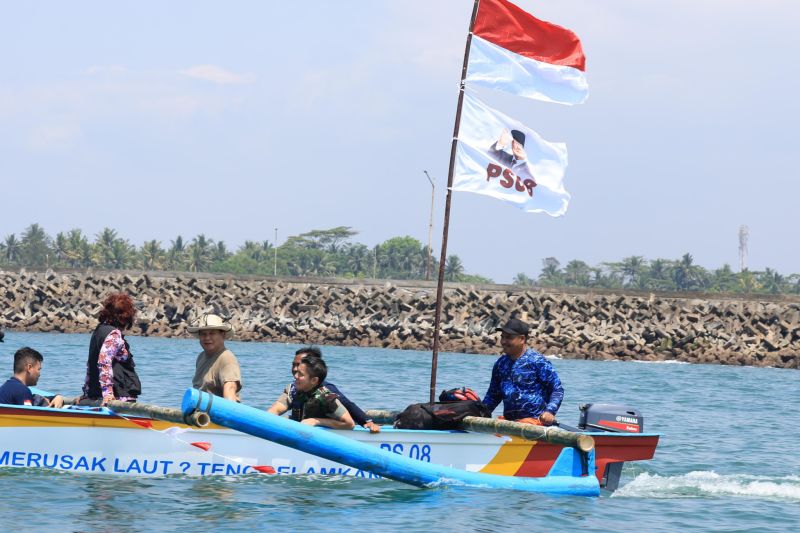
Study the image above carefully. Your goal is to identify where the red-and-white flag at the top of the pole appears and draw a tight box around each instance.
[466,0,589,105]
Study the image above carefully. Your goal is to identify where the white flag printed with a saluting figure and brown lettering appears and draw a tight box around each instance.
[452,92,570,216]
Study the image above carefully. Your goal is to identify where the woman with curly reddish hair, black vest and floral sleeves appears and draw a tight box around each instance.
[83,292,142,404]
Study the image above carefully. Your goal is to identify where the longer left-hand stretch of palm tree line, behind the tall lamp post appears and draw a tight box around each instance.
[0,223,492,283]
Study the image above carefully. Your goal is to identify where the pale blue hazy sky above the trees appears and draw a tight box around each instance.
[0,0,800,283]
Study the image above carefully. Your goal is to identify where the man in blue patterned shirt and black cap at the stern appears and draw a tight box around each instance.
[483,318,564,426]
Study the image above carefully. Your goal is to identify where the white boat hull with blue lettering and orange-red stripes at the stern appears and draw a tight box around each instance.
[0,392,659,490]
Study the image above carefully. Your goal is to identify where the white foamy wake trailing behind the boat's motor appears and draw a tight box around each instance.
[613,471,800,501]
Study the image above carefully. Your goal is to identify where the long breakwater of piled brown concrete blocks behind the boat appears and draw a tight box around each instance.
[0,270,800,368]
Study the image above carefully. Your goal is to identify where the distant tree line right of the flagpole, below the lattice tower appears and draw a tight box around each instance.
[513,253,800,294]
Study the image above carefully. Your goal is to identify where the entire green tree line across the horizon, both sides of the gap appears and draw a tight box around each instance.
[0,224,800,294]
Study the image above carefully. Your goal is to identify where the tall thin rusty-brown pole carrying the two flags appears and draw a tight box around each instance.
[430,0,480,402]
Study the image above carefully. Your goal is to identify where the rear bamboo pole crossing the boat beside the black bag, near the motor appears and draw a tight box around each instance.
[367,409,594,452]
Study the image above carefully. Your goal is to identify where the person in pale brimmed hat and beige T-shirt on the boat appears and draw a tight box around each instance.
[188,314,242,402]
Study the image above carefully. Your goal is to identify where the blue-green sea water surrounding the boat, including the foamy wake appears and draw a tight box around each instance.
[0,331,800,532]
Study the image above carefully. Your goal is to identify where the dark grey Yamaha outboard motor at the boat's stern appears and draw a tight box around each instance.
[578,403,644,491]
